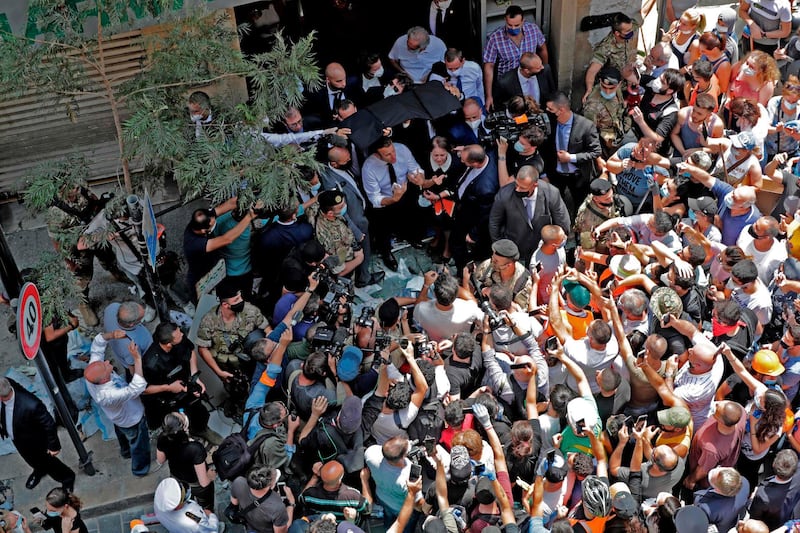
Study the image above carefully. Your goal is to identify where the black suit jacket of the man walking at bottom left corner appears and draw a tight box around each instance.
[6,379,61,453]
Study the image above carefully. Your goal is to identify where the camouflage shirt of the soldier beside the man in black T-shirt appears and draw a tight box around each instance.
[197,302,268,370]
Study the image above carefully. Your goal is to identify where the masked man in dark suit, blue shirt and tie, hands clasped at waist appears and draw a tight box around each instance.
[542,91,601,217]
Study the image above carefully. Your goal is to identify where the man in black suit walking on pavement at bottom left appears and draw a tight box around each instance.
[0,378,75,491]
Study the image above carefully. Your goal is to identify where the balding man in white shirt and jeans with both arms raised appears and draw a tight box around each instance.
[83,329,150,477]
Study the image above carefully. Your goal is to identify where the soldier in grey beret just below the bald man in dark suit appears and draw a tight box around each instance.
[461,239,532,309]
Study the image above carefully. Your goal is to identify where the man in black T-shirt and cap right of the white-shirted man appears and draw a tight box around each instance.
[142,322,216,444]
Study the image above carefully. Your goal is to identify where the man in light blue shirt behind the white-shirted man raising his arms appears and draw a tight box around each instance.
[103,300,153,379]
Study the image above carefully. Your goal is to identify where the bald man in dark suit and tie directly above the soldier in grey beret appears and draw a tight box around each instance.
[489,162,570,265]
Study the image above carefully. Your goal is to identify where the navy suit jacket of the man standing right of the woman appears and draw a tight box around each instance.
[453,156,499,242]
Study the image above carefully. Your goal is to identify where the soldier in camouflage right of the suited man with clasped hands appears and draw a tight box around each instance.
[583,67,631,159]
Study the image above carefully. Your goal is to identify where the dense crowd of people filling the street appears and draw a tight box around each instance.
[6,0,800,533]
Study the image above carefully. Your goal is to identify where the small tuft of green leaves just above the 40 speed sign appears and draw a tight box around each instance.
[27,252,84,324]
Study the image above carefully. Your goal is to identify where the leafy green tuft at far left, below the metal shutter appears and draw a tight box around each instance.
[23,154,89,213]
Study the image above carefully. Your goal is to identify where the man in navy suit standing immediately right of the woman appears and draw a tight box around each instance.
[450,144,499,272]
